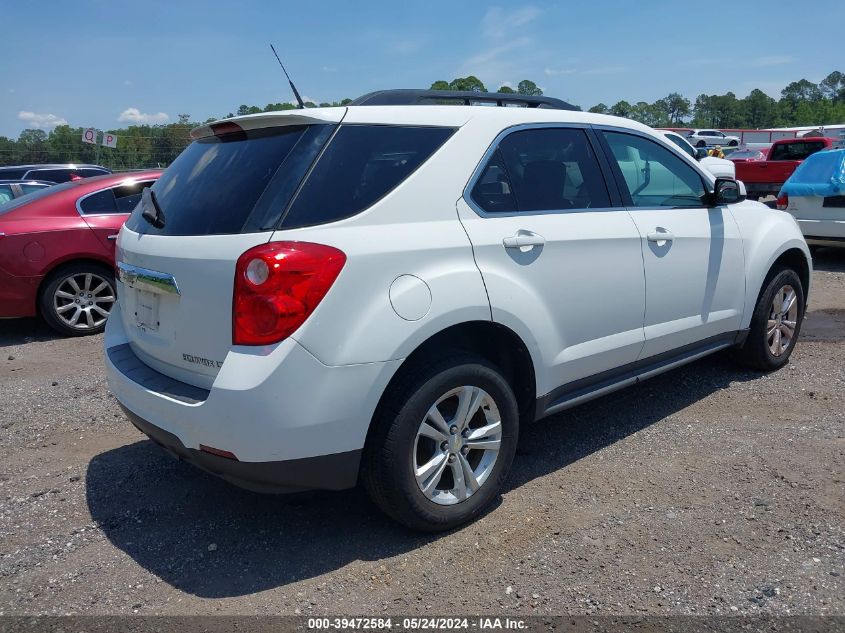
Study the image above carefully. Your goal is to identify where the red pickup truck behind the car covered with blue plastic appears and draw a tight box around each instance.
[735,137,835,200]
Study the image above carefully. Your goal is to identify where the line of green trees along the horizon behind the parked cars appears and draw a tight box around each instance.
[0,71,845,170]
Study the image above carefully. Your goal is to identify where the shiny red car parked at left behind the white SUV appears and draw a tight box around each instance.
[0,170,162,336]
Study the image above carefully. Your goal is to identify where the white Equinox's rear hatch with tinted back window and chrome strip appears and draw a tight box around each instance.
[117,108,345,388]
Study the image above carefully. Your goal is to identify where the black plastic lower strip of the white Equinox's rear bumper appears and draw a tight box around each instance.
[121,405,361,493]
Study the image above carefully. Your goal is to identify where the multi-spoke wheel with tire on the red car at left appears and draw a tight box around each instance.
[38,262,116,336]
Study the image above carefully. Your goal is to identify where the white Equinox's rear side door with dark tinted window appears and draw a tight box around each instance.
[458,125,645,400]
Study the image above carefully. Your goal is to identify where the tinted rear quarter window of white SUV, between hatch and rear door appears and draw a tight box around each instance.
[282,125,455,229]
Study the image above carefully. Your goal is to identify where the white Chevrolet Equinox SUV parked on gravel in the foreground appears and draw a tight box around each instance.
[105,91,811,530]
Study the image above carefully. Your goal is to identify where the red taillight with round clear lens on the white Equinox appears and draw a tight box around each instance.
[232,242,346,345]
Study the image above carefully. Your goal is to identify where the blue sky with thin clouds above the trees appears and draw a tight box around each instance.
[0,0,845,138]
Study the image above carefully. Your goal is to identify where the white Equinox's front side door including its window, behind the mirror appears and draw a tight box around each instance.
[601,130,745,358]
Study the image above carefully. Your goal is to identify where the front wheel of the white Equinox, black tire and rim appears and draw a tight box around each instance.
[737,267,804,371]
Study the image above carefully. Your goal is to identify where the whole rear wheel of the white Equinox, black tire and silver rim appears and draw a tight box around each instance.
[362,354,519,532]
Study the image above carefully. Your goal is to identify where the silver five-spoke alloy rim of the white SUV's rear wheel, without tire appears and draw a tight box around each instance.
[412,386,502,505]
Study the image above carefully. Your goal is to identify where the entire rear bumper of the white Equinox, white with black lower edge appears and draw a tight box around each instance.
[105,303,400,491]
